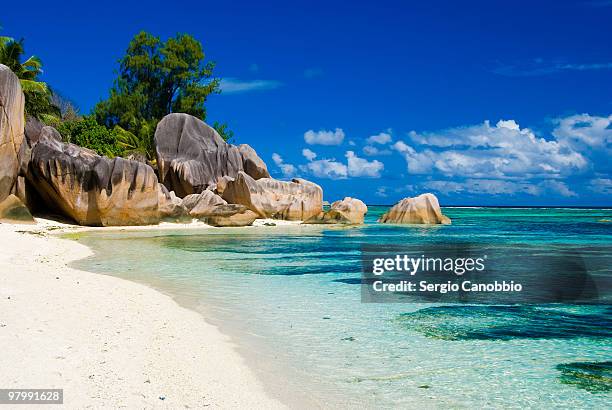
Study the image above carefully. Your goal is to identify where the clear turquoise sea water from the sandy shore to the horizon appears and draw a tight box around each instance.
[71,207,612,408]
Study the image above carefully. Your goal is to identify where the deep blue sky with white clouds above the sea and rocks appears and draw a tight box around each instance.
[0,0,612,206]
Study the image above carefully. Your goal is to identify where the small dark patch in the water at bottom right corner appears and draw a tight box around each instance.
[557,362,612,393]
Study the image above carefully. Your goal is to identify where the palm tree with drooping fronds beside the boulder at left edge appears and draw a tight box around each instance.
[0,36,58,118]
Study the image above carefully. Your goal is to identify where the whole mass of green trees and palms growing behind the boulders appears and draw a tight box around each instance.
[0,26,234,162]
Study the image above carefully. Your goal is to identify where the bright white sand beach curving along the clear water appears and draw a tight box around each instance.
[0,221,283,409]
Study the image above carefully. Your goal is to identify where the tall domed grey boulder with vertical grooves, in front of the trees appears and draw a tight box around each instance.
[155,113,270,198]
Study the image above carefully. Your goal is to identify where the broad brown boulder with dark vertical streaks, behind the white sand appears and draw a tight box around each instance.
[28,131,160,226]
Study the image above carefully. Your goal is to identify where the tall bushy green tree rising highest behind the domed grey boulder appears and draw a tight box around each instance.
[94,32,219,145]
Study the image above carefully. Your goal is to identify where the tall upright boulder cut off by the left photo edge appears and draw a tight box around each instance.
[0,64,27,201]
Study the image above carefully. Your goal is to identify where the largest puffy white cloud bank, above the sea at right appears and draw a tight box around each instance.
[392,120,587,179]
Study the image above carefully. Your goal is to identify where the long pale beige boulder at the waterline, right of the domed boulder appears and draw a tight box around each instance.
[222,172,323,221]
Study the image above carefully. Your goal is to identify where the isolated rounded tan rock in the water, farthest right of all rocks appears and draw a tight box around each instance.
[378,194,451,225]
